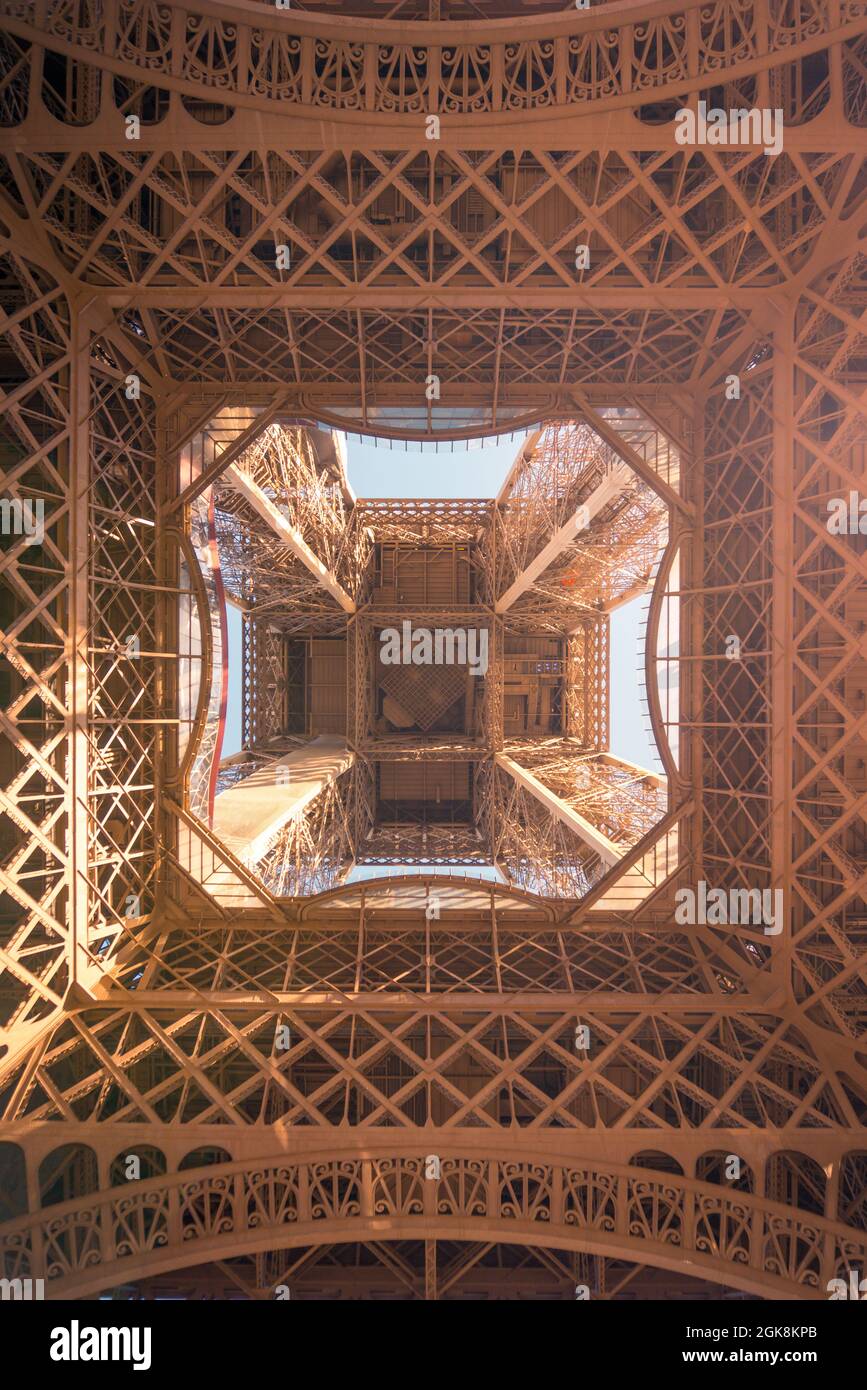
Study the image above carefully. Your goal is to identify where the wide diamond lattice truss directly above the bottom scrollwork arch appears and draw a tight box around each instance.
[7,984,860,1134]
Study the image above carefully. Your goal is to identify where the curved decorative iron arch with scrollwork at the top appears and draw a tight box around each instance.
[6,0,861,128]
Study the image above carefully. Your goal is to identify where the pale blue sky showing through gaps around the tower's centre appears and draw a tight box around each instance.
[222,434,661,771]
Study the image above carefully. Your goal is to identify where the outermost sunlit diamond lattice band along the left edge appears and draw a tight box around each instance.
[0,256,73,1045]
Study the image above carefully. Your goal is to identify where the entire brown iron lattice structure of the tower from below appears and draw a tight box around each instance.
[0,0,867,1300]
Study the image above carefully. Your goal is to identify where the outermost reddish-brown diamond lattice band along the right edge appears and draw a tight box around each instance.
[781,254,867,1040]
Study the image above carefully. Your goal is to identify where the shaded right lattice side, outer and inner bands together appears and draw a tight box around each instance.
[689,256,867,1037]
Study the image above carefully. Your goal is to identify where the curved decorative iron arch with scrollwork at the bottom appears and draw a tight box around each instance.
[0,1145,867,1298]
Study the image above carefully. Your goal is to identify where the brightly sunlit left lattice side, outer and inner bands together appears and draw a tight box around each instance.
[0,254,163,1073]
